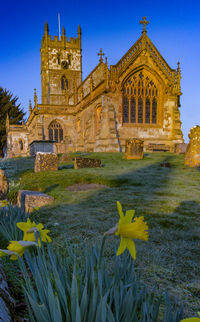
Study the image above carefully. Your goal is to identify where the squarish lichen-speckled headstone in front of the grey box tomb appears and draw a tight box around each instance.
[34,152,58,172]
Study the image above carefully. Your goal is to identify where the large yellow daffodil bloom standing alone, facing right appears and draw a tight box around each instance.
[106,201,148,259]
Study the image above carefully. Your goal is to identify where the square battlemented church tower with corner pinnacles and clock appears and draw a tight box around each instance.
[40,22,82,105]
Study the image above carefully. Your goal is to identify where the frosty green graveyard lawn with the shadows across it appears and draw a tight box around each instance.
[0,153,200,316]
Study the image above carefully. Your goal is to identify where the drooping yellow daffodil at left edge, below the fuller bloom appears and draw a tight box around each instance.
[0,240,37,260]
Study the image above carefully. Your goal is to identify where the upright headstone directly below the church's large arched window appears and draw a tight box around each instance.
[125,139,144,160]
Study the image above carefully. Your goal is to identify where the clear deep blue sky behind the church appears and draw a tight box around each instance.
[0,0,200,142]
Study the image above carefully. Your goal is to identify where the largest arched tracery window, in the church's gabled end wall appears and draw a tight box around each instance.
[123,72,158,124]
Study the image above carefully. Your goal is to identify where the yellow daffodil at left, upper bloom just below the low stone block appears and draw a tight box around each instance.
[17,218,51,247]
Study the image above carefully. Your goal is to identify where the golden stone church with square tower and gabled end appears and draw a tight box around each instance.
[6,17,183,157]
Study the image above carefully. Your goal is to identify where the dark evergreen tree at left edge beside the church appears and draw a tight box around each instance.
[0,86,25,155]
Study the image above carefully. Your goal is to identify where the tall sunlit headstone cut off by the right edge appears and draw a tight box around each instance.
[185,125,200,167]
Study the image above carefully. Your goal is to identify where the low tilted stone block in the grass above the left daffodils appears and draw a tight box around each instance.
[18,190,54,213]
